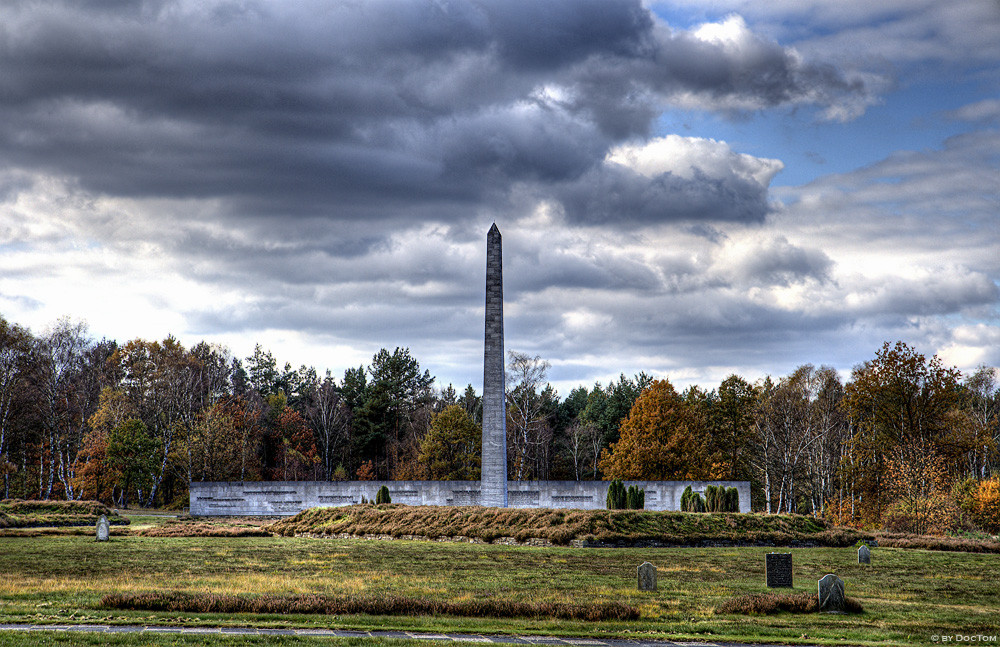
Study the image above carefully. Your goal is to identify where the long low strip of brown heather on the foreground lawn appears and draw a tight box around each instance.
[100,591,639,622]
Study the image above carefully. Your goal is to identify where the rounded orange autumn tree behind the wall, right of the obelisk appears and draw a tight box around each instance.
[600,380,710,481]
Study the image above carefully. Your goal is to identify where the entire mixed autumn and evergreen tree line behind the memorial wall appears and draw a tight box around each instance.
[0,317,1000,525]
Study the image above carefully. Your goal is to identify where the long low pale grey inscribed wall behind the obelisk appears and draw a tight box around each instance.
[191,481,750,516]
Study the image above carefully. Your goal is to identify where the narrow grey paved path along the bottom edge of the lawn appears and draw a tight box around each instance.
[0,624,812,647]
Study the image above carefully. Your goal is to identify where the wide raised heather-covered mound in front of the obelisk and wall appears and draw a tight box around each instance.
[266,505,871,546]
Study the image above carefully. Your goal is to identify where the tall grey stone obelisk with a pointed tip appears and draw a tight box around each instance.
[479,223,507,508]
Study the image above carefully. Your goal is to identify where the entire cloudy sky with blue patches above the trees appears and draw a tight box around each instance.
[0,0,1000,395]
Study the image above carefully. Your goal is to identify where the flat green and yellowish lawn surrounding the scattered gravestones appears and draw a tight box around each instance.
[0,519,1000,645]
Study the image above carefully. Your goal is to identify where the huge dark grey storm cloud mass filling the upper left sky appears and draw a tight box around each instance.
[0,0,869,228]
